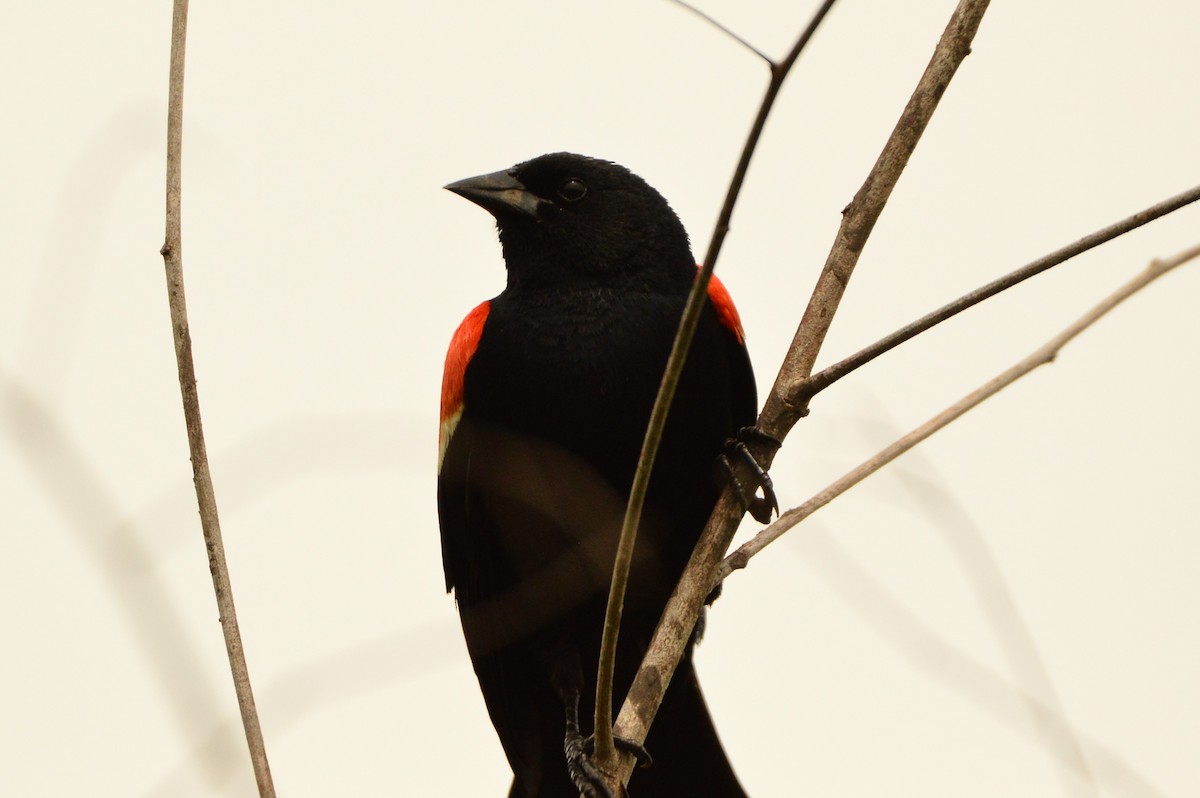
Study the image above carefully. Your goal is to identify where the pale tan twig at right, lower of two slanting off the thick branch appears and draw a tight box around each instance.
[716,245,1200,582]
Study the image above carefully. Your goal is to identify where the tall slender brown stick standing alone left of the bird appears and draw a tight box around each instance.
[161,0,275,798]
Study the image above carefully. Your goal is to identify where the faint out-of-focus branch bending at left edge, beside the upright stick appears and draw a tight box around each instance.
[0,85,231,790]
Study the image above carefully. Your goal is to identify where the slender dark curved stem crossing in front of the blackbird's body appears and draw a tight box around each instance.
[593,0,835,772]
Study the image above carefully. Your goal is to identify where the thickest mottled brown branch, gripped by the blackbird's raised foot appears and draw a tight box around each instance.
[616,0,988,781]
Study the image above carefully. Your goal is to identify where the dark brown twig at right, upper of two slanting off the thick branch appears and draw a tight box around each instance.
[796,186,1200,406]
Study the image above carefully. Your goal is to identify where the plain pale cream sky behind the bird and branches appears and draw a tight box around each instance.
[0,0,1200,798]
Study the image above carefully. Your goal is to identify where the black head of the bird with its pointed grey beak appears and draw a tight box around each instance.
[446,152,695,291]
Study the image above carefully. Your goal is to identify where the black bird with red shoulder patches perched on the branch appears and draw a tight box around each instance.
[438,152,756,798]
